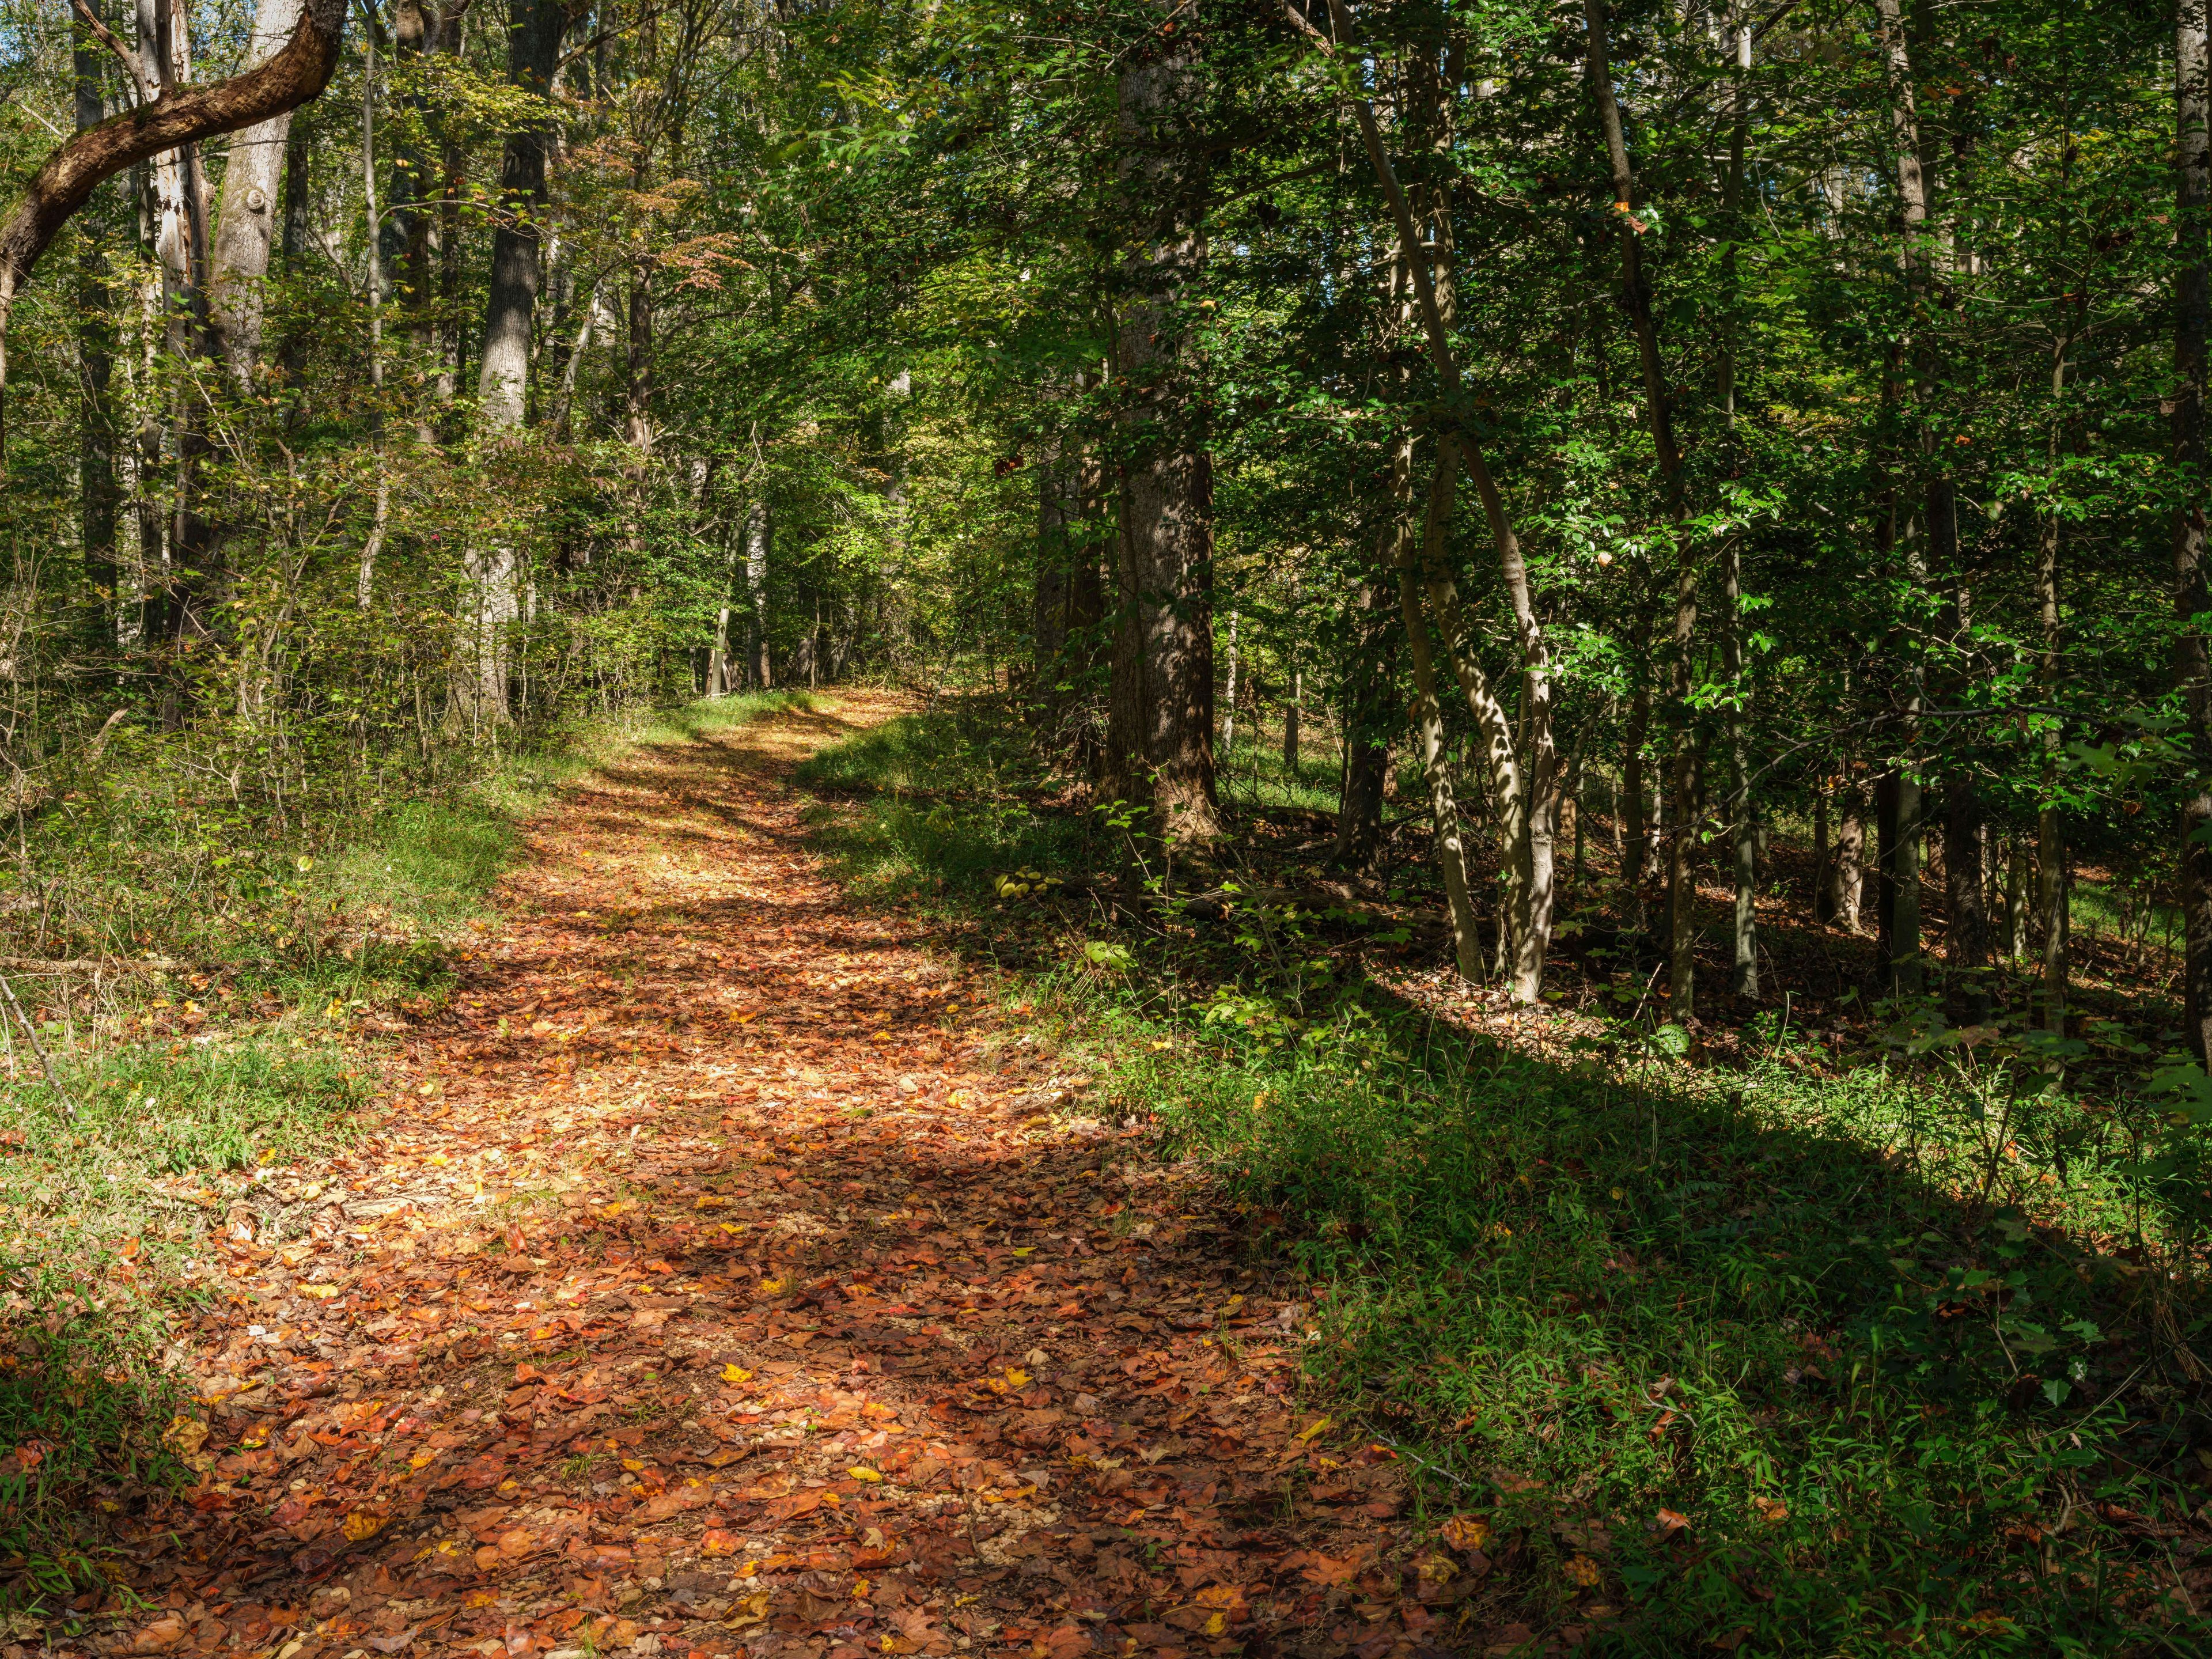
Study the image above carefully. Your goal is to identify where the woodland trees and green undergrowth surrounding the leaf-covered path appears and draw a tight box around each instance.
[0,0,2212,1652]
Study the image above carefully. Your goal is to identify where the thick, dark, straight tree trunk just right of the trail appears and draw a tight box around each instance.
[1115,5,1221,843]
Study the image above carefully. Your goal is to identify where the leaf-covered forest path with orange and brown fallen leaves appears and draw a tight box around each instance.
[108,695,1468,1659]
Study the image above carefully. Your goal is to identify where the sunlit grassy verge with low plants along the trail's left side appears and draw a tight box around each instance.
[0,695,803,1601]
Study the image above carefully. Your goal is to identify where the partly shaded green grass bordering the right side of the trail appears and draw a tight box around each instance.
[809,714,2212,1654]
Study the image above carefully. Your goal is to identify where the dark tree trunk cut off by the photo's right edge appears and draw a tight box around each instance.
[2168,0,2212,1064]
